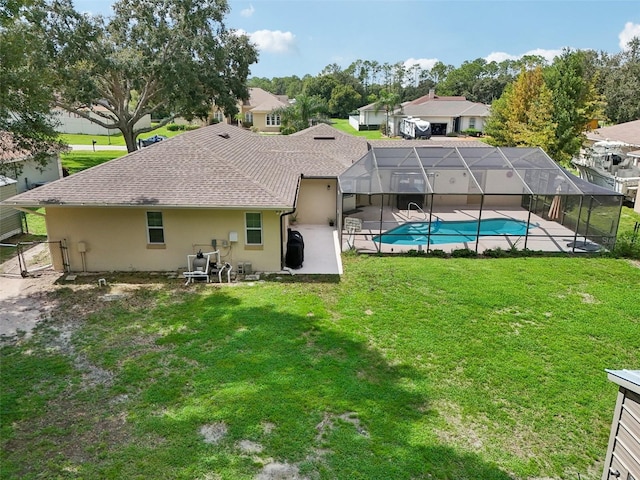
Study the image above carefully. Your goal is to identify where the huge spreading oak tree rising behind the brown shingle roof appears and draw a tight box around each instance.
[43,0,257,152]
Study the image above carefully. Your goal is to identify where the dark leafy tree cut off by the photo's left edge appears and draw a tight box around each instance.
[0,0,65,173]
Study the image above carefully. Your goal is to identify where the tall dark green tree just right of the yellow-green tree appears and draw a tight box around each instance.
[545,50,602,164]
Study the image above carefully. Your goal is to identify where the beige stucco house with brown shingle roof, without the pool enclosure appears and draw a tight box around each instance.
[3,123,368,272]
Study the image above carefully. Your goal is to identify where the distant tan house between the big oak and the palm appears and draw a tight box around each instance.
[213,88,289,133]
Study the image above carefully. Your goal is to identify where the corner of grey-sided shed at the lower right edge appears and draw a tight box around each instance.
[602,370,640,480]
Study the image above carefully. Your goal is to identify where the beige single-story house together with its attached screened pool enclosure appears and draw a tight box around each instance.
[0,123,622,273]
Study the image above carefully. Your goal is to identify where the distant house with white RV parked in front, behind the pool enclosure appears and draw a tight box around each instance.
[389,89,489,136]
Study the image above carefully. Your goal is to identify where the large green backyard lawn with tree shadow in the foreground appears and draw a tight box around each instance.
[0,255,640,480]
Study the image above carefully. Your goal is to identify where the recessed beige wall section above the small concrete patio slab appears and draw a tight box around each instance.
[296,178,337,225]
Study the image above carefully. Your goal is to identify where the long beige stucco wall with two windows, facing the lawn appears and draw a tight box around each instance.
[46,207,282,272]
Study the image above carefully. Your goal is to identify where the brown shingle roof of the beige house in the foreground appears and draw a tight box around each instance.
[7,123,368,209]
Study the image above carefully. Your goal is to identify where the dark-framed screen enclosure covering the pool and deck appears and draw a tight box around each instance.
[339,146,623,253]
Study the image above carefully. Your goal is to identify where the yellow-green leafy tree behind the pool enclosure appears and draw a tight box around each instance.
[485,67,556,151]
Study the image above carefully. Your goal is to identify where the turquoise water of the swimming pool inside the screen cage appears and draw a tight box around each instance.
[373,218,536,245]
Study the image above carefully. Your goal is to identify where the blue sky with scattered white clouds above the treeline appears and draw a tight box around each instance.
[75,0,640,78]
